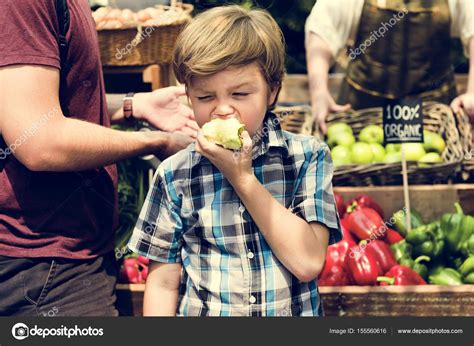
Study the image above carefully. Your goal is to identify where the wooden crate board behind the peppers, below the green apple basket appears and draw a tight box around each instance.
[334,184,474,222]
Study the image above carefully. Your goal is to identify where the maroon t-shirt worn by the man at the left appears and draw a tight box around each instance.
[0,0,117,259]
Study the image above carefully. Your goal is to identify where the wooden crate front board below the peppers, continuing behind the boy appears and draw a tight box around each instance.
[117,285,474,317]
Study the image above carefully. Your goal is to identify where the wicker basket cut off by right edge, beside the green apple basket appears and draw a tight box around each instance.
[456,109,474,181]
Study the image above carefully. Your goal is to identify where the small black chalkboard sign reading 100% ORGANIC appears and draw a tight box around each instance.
[383,98,423,144]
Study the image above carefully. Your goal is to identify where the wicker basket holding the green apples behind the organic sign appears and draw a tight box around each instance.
[327,102,463,186]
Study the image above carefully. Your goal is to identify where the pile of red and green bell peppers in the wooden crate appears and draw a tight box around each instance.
[318,193,474,286]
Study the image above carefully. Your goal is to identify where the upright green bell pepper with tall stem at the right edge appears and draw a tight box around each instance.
[441,203,474,253]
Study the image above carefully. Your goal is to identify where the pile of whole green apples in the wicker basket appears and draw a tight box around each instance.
[327,122,446,167]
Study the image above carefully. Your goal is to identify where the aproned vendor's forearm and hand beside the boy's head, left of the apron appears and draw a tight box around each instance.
[306,32,351,133]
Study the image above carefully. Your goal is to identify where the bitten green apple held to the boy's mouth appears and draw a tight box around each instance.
[202,118,245,150]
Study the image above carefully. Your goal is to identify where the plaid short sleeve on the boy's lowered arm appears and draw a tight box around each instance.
[128,165,183,263]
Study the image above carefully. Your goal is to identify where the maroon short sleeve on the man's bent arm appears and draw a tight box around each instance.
[0,0,60,69]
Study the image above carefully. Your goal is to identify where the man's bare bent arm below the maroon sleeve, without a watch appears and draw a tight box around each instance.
[0,65,191,171]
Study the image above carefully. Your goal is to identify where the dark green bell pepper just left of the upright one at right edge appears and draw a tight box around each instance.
[405,221,444,258]
